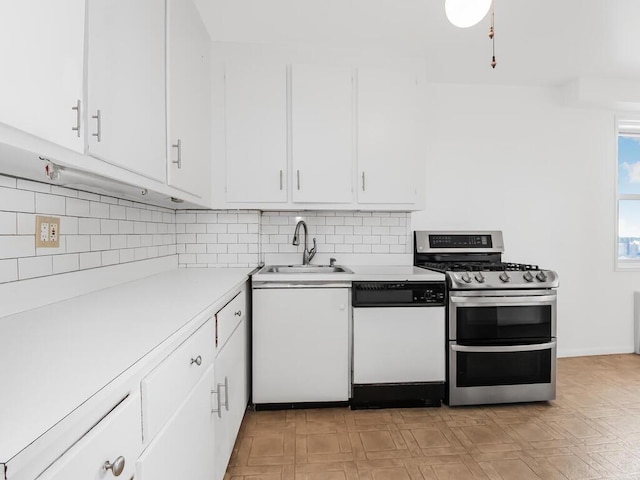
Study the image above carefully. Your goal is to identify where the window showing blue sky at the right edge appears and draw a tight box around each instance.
[617,120,640,268]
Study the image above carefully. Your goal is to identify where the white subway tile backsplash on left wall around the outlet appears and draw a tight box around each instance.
[0,175,177,283]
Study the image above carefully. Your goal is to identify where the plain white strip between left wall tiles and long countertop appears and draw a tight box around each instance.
[0,255,178,318]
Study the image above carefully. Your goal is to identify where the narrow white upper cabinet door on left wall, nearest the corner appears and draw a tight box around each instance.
[167,0,212,198]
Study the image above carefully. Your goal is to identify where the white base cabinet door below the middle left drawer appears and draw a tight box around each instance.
[136,365,215,480]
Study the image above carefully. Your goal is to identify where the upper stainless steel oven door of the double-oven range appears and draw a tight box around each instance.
[448,290,557,345]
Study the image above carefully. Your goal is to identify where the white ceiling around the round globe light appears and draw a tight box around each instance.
[196,0,640,85]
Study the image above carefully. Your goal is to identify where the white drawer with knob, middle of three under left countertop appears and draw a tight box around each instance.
[142,319,214,443]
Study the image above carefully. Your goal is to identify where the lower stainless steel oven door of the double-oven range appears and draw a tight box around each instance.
[449,339,556,405]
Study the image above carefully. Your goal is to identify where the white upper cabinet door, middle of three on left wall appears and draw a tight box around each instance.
[87,0,167,183]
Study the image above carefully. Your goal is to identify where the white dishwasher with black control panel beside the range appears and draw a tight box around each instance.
[351,282,446,408]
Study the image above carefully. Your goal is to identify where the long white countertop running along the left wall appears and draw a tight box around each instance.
[0,268,252,463]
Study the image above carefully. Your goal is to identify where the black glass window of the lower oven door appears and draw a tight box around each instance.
[456,349,551,387]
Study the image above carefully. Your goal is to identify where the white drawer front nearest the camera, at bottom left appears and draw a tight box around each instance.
[38,393,142,480]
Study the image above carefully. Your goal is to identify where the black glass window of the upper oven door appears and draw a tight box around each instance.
[456,305,552,345]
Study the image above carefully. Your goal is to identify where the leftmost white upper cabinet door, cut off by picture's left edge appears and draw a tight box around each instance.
[0,0,85,153]
